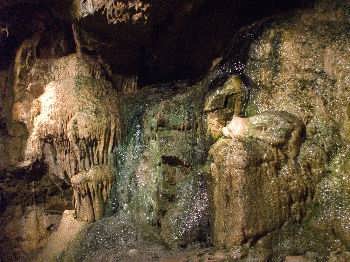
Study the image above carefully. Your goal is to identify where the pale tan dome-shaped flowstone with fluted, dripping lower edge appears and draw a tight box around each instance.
[8,33,120,222]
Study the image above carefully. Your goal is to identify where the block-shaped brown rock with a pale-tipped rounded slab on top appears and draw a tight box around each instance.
[210,112,308,247]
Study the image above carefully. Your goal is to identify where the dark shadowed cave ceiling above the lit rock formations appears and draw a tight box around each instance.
[0,0,313,81]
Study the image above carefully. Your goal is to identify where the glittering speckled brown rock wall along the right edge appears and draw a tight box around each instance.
[246,1,350,252]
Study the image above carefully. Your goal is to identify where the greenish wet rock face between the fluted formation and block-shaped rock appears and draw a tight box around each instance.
[115,83,208,247]
